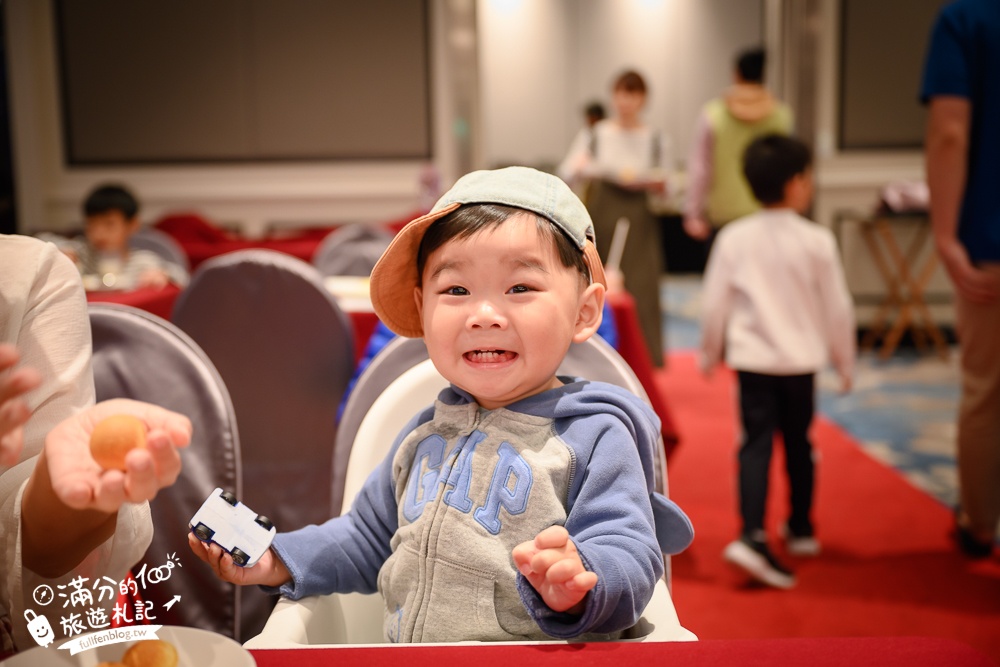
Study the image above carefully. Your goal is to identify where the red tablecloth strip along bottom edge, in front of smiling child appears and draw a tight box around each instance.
[250,637,996,667]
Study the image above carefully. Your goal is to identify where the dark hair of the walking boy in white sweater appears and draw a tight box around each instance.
[743,134,812,204]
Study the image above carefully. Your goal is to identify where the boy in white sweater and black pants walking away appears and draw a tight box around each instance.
[701,134,855,588]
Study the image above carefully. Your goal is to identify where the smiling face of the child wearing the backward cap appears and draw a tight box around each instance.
[415,213,604,410]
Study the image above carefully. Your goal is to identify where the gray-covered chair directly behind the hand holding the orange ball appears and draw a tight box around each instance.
[88,303,249,640]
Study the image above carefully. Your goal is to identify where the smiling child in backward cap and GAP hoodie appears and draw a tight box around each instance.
[189,167,693,642]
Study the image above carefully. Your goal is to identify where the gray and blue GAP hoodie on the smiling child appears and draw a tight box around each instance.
[273,378,692,642]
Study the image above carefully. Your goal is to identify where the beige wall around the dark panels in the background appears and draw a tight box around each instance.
[3,0,951,328]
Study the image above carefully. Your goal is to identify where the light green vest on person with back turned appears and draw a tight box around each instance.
[705,98,792,227]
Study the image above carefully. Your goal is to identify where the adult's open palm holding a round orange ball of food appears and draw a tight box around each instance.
[43,398,191,513]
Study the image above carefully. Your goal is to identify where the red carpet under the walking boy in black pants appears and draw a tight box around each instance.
[658,353,1000,663]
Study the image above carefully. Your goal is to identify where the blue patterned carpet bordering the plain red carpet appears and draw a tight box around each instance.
[660,275,959,507]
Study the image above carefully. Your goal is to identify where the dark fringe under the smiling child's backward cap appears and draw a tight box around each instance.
[417,204,590,284]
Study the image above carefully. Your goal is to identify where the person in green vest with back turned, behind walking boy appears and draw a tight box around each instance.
[684,48,792,245]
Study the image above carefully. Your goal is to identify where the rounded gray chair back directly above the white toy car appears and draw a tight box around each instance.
[172,250,354,531]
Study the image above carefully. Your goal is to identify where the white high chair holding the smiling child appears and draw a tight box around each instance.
[244,339,697,649]
